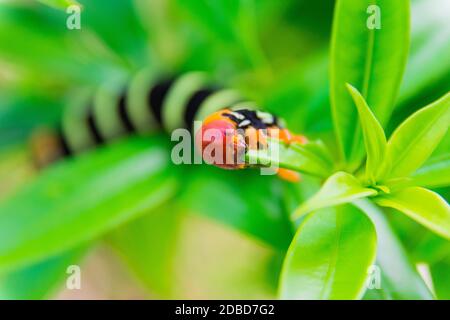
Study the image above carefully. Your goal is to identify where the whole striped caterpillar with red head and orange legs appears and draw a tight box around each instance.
[31,70,306,181]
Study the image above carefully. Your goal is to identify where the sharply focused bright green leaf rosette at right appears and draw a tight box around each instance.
[260,1,450,299]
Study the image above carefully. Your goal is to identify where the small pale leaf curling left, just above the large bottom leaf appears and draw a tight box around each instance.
[293,172,377,219]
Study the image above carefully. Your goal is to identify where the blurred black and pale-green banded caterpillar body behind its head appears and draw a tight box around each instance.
[33,70,239,165]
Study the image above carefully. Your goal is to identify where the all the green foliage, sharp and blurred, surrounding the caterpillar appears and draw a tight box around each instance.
[0,0,450,299]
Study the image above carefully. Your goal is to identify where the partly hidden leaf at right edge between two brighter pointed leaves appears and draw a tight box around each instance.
[412,153,450,188]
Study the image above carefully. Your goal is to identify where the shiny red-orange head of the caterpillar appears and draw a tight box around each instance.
[195,109,247,169]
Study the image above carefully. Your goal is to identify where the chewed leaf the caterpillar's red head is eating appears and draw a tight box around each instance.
[245,139,333,177]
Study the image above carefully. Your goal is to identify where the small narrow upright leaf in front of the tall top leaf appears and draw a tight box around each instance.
[347,84,386,183]
